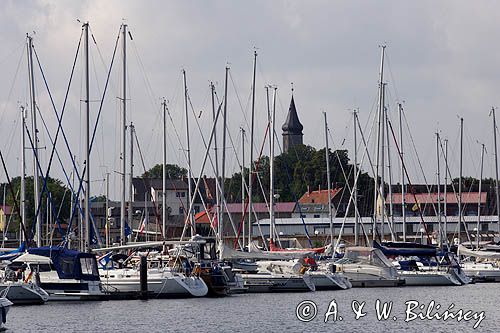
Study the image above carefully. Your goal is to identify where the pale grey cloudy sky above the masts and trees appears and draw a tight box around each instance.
[0,0,500,198]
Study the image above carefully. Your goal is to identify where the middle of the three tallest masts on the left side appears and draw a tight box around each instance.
[83,22,90,252]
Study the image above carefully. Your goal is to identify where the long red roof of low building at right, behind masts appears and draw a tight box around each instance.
[385,192,487,204]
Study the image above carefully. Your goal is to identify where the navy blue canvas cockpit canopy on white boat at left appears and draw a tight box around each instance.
[24,246,99,281]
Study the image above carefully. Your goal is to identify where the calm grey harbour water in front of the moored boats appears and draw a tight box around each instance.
[5,284,500,333]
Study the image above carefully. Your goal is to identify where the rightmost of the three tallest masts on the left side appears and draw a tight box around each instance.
[120,24,127,245]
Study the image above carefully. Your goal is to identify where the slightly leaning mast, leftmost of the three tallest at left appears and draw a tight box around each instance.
[27,36,43,246]
